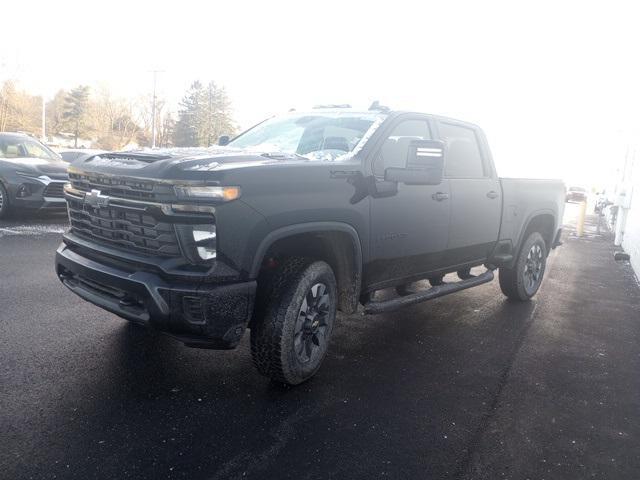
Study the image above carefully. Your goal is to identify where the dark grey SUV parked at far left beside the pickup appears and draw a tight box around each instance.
[0,132,68,218]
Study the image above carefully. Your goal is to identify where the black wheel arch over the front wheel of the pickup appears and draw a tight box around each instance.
[249,222,362,313]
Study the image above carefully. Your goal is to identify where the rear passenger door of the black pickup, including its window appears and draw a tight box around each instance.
[437,120,502,266]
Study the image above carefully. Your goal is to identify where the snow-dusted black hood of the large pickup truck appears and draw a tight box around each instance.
[69,147,349,180]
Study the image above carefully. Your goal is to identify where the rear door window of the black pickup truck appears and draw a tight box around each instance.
[438,122,486,178]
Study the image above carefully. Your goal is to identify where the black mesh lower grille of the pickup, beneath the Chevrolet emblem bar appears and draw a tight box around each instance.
[67,197,181,257]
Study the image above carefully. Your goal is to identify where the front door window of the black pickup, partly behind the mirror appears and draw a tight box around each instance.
[373,120,432,177]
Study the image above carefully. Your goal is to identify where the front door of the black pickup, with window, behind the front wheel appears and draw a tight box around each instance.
[364,116,450,288]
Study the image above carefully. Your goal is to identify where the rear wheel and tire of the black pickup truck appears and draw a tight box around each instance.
[499,232,547,302]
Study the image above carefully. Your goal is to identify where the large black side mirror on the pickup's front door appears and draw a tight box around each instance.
[384,140,444,185]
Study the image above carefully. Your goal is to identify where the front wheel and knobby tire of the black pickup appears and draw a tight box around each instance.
[251,258,337,385]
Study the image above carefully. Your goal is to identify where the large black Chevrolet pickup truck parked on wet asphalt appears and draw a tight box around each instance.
[56,107,565,384]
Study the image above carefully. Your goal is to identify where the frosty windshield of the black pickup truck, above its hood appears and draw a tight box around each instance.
[229,112,385,160]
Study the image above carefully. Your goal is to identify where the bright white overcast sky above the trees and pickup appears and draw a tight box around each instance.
[0,0,640,182]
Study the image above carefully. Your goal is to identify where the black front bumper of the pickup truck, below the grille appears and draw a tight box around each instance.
[56,243,256,349]
